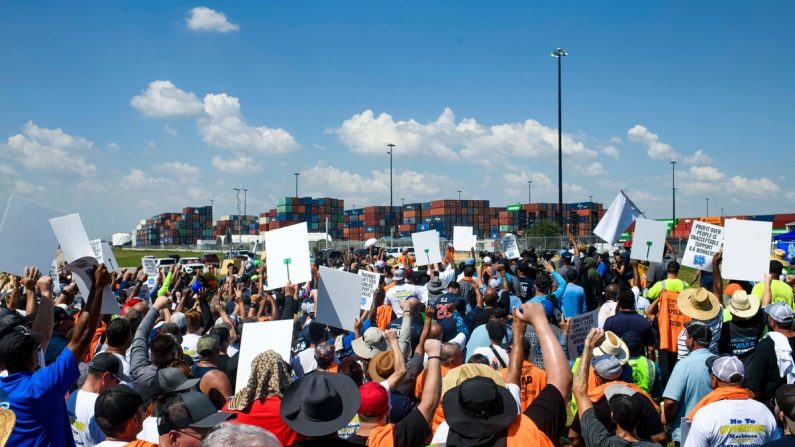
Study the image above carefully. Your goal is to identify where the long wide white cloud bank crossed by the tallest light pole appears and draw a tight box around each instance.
[330,108,598,163]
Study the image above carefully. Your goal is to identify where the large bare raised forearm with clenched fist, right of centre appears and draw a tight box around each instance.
[522,301,571,400]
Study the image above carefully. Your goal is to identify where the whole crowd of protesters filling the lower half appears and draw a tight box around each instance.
[0,238,795,447]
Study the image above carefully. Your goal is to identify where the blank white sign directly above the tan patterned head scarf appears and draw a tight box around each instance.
[235,320,293,393]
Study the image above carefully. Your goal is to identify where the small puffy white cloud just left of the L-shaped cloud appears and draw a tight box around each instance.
[130,81,204,118]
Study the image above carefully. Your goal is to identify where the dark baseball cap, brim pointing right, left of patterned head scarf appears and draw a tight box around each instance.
[157,391,237,435]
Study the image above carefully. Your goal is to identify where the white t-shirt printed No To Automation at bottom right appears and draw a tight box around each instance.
[684,399,776,447]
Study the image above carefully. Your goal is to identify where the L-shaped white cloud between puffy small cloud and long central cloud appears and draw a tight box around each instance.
[197,93,299,154]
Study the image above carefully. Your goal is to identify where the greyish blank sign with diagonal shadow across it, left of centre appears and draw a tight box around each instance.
[315,266,363,332]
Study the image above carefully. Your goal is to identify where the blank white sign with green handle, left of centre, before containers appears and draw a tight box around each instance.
[265,222,312,290]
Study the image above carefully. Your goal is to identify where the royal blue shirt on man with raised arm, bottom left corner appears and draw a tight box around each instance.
[0,349,80,447]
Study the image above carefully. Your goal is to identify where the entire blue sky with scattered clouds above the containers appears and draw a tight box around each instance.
[0,1,795,236]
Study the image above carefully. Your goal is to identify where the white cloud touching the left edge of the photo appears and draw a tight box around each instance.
[1,121,97,177]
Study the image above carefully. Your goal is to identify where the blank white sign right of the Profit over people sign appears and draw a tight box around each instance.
[721,219,773,281]
